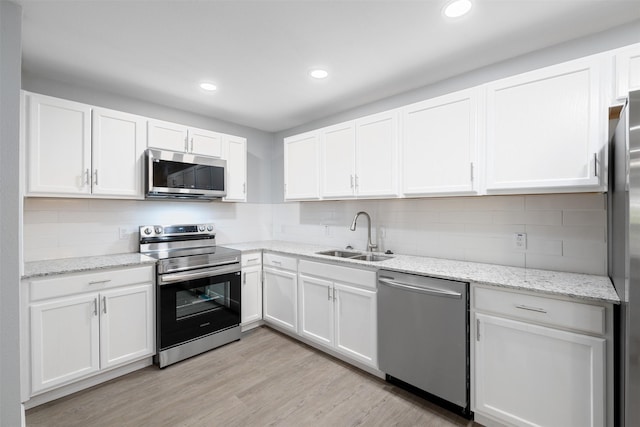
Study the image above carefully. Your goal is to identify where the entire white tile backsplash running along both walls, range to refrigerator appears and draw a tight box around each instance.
[24,193,607,275]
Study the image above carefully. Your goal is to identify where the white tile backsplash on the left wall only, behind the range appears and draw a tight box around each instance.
[24,197,271,262]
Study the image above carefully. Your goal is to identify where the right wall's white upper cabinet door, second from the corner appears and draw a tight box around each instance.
[321,122,356,199]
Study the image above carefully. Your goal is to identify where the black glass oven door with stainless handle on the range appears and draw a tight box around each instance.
[157,264,241,350]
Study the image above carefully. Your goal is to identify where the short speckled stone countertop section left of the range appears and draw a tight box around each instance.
[22,253,156,279]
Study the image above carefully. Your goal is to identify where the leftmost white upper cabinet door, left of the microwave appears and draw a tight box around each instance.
[25,94,91,195]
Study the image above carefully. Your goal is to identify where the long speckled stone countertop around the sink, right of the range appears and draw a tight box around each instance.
[223,241,620,304]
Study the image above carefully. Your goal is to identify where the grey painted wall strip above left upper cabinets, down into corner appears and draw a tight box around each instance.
[22,72,274,203]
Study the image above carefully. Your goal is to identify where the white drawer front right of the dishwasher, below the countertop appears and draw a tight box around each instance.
[473,287,605,335]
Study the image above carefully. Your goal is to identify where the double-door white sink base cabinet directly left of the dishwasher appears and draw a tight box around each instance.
[298,260,378,368]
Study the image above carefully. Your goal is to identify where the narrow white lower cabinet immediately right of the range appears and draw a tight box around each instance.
[240,252,262,330]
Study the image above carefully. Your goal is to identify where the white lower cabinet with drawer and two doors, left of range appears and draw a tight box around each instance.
[25,266,155,395]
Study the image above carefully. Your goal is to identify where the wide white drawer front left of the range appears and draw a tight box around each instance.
[29,266,154,301]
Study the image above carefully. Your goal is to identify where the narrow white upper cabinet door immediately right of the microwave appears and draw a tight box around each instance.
[224,135,247,202]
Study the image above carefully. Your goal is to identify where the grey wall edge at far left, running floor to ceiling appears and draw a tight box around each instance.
[0,1,22,426]
